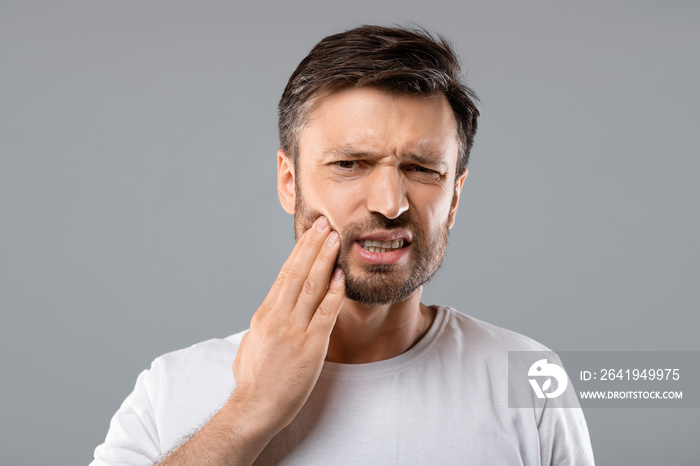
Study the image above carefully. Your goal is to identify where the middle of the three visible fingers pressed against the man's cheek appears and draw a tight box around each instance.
[293,231,340,327]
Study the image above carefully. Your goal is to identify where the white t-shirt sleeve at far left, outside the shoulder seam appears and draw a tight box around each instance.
[90,367,161,466]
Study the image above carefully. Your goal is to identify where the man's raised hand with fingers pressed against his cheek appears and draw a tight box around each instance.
[232,216,345,429]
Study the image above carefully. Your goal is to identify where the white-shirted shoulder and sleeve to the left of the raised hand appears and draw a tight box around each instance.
[95,332,252,464]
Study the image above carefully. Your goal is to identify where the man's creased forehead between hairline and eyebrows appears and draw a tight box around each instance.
[299,86,459,167]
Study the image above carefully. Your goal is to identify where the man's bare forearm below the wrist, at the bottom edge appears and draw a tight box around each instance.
[159,392,282,466]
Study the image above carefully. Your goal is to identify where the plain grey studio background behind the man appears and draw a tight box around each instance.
[0,0,700,465]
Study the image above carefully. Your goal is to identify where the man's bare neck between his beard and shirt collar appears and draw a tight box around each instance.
[326,288,436,364]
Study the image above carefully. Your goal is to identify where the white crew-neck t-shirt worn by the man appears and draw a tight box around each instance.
[92,307,593,466]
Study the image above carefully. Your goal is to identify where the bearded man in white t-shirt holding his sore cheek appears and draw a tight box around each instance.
[93,26,593,465]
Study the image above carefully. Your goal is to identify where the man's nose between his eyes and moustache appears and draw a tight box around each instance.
[366,166,408,219]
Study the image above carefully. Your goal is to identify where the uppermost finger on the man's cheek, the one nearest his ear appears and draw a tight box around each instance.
[275,217,330,312]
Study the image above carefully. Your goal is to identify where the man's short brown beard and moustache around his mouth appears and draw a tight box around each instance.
[294,184,450,305]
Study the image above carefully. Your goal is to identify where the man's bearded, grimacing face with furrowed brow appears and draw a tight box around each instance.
[283,87,466,304]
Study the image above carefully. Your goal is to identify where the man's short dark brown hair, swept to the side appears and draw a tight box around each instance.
[279,26,479,174]
